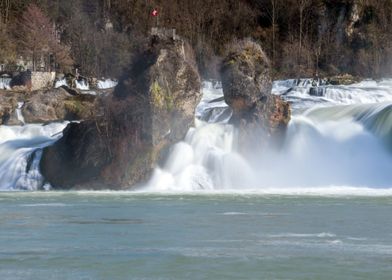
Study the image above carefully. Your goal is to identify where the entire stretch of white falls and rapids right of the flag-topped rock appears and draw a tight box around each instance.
[143,80,392,193]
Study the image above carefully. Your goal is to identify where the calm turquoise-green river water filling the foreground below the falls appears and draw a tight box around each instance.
[0,192,392,279]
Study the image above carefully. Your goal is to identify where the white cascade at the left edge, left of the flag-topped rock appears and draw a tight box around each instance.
[0,123,66,190]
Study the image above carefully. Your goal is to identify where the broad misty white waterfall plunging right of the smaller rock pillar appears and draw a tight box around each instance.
[257,112,392,188]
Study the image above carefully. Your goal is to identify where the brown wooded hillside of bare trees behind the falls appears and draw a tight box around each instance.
[0,0,392,77]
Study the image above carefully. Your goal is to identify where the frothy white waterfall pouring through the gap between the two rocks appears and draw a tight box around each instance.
[147,122,252,191]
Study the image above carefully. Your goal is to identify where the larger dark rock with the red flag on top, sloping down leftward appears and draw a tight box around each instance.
[41,35,201,189]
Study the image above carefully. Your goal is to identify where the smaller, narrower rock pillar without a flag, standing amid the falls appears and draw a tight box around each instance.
[221,40,290,153]
